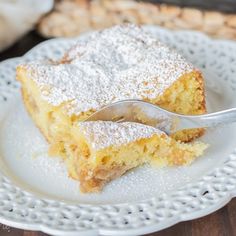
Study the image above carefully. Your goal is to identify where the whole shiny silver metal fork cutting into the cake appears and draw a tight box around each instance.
[86,99,236,134]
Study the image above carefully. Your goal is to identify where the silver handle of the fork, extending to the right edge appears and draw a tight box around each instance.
[176,108,236,131]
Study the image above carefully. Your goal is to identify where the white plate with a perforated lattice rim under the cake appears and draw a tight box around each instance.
[0,26,236,235]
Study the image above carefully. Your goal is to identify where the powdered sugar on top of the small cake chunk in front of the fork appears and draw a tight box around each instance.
[79,121,165,150]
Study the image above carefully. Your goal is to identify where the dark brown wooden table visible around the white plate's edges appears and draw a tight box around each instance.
[0,32,236,236]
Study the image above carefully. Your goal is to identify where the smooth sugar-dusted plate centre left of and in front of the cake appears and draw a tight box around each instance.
[0,102,208,204]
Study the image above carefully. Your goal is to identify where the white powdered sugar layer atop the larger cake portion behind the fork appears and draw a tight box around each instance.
[24,25,193,115]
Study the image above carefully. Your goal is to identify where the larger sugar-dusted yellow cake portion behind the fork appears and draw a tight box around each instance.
[17,25,206,191]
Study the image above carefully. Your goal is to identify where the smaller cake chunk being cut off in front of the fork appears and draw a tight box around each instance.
[66,121,207,192]
